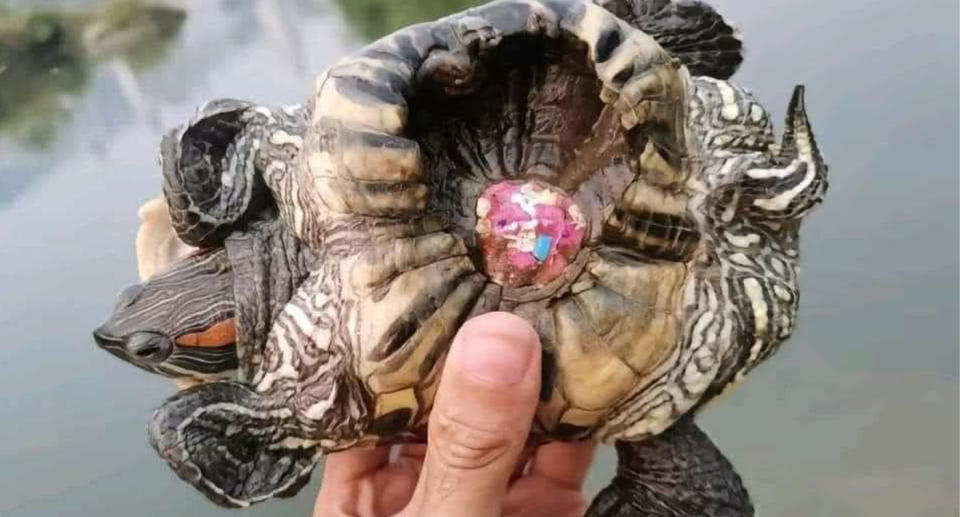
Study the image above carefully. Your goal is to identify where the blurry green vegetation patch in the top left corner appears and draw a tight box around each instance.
[0,0,186,147]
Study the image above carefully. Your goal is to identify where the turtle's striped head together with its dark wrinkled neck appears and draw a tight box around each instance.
[94,220,313,384]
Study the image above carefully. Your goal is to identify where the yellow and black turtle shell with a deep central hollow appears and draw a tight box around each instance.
[281,2,701,436]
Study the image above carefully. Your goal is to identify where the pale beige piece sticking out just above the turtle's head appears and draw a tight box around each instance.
[136,197,196,282]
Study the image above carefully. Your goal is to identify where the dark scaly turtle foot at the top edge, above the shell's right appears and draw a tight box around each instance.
[594,0,743,79]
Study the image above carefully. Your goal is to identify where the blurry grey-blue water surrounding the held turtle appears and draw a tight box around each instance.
[0,0,958,517]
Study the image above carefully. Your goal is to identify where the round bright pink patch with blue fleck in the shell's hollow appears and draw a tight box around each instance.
[477,181,586,287]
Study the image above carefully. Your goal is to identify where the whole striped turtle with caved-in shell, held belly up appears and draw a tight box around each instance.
[92,0,827,516]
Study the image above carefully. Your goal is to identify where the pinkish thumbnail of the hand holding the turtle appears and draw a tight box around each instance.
[454,313,539,385]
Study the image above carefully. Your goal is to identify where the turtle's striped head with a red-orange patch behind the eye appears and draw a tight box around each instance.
[93,248,237,381]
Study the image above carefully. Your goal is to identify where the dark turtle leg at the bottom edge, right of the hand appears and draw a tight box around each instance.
[586,417,754,517]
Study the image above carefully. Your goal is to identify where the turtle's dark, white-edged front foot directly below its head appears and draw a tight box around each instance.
[147,382,319,507]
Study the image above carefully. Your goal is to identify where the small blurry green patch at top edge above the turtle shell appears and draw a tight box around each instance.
[337,0,486,39]
